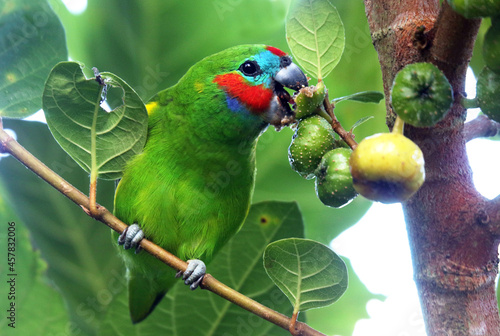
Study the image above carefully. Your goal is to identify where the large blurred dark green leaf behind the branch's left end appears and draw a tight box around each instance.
[0,120,121,335]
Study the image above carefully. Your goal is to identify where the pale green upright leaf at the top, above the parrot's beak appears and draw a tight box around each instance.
[286,0,345,79]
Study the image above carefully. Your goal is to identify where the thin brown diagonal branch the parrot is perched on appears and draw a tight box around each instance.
[0,124,325,336]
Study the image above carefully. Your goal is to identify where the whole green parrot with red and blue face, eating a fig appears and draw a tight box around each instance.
[114,45,308,323]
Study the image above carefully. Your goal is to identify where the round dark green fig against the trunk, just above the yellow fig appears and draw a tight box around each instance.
[391,63,453,127]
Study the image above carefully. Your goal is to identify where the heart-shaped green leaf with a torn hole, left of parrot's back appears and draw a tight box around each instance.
[43,62,148,179]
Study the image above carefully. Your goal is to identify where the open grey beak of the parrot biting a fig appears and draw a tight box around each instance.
[268,56,309,130]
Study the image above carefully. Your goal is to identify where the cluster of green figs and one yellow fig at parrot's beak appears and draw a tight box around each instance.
[288,63,453,208]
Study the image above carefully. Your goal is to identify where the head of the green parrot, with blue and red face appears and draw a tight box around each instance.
[170,45,308,139]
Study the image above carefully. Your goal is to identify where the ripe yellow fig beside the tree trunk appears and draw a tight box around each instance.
[350,133,425,203]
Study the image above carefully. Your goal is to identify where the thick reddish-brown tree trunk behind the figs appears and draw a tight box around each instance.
[365,0,500,336]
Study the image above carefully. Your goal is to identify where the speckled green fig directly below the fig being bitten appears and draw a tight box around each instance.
[288,116,335,179]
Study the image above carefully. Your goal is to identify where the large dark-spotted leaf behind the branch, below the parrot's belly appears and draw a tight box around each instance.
[100,202,304,336]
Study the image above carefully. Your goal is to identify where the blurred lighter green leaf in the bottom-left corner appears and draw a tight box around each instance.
[0,180,69,335]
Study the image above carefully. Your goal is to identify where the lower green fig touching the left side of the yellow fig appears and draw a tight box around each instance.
[315,148,358,208]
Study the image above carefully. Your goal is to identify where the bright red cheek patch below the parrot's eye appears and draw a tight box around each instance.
[213,73,273,114]
